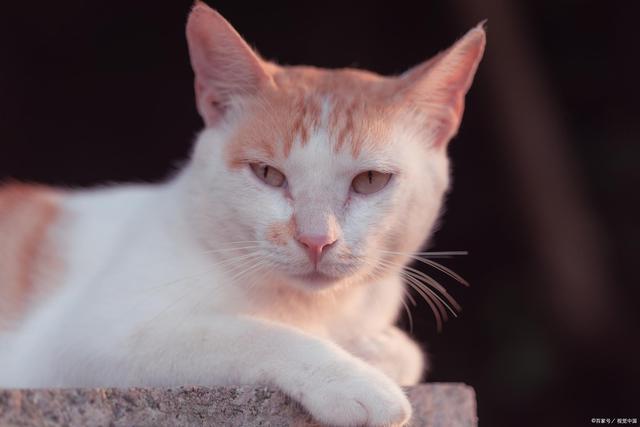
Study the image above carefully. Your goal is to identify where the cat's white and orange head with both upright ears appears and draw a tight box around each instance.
[187,3,485,289]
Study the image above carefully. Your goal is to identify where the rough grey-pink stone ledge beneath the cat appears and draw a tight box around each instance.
[0,383,477,427]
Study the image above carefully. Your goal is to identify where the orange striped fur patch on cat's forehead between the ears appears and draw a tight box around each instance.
[228,67,397,165]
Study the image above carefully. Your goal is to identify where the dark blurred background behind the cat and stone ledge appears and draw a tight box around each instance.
[0,0,640,426]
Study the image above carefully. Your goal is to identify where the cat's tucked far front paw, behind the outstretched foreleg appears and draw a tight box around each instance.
[343,326,427,386]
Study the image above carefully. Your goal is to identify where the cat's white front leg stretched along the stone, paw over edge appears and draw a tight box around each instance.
[131,317,411,426]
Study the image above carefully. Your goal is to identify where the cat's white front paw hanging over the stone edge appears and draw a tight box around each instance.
[300,364,411,426]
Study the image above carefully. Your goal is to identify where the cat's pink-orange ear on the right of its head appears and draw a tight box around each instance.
[400,22,486,147]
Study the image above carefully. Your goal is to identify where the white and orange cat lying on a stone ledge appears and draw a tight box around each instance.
[0,2,486,426]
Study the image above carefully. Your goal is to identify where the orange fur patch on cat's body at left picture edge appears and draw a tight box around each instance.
[0,184,59,323]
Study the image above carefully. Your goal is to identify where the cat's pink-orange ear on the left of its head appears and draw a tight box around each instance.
[187,1,270,126]
